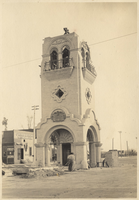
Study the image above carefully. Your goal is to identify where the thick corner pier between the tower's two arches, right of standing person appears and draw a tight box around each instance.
[75,142,88,169]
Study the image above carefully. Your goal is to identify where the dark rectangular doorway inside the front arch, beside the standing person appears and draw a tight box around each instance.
[62,143,71,165]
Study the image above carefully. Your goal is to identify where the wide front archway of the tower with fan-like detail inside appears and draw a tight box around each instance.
[45,128,74,166]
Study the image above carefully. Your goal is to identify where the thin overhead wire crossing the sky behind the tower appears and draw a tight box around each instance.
[3,32,137,69]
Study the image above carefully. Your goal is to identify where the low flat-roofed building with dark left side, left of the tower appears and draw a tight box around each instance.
[2,129,33,164]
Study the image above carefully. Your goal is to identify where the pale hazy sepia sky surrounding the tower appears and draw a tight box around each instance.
[1,2,138,150]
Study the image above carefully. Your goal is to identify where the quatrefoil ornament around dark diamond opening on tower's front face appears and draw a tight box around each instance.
[52,85,68,103]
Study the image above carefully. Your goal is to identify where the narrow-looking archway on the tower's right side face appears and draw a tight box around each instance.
[87,126,97,167]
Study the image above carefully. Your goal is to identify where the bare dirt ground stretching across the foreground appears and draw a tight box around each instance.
[2,156,137,199]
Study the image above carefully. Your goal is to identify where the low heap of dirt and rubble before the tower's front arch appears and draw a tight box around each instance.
[21,168,64,178]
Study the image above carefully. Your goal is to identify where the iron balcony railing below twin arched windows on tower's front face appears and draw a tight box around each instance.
[44,58,73,71]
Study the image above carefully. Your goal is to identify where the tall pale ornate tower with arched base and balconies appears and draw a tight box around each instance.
[35,29,101,168]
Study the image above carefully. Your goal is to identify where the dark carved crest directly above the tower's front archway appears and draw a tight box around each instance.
[51,109,66,122]
